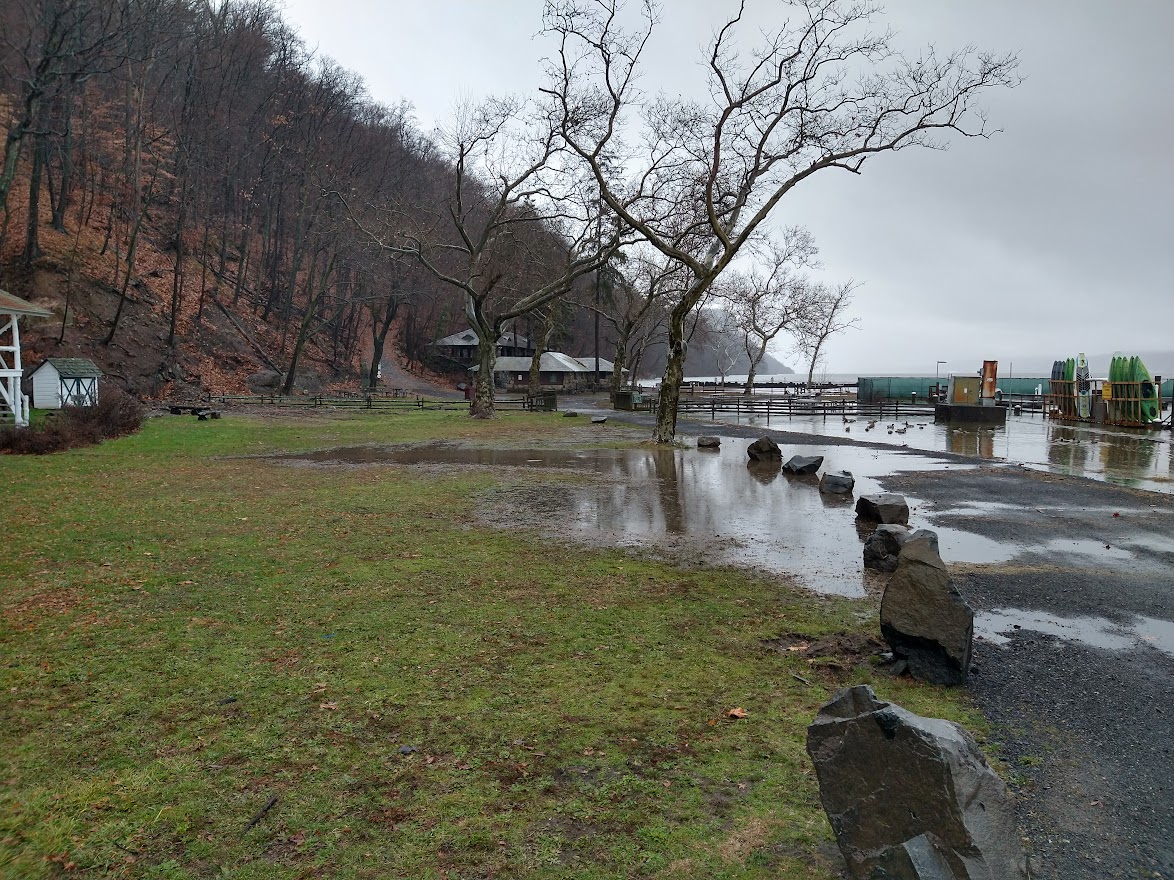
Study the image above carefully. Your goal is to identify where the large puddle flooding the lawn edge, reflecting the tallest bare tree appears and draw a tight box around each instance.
[282,438,1010,597]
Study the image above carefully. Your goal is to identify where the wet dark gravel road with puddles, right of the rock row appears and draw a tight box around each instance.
[614,413,1174,880]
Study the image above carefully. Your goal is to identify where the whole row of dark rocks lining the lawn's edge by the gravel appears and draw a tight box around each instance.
[697,436,1028,880]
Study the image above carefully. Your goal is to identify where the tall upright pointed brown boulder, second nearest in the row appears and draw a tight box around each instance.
[881,536,974,684]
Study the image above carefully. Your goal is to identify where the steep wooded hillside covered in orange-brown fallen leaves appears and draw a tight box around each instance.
[0,0,587,397]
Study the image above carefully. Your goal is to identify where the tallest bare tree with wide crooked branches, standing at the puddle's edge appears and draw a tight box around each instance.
[544,0,1017,442]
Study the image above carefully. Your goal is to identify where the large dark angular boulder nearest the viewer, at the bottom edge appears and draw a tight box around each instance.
[807,684,1027,880]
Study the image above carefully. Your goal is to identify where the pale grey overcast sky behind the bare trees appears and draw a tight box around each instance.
[285,0,1174,374]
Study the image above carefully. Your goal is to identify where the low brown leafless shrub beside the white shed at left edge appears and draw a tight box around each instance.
[0,385,144,455]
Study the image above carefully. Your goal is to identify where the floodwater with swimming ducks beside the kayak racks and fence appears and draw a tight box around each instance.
[704,413,1174,493]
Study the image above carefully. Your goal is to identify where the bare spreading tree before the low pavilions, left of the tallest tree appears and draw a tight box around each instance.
[352,97,619,418]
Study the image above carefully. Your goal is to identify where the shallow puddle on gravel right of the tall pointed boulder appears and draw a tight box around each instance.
[974,608,1174,656]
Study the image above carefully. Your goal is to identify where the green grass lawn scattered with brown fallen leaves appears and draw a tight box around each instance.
[0,412,981,880]
